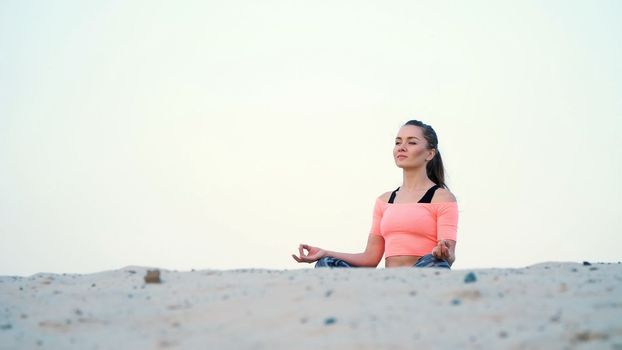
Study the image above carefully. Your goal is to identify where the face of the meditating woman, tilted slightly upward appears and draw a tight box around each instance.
[393,125,435,168]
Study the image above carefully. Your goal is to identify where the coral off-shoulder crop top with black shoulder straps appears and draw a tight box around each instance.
[371,186,458,257]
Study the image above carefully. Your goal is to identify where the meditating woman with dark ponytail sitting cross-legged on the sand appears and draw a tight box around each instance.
[292,120,458,269]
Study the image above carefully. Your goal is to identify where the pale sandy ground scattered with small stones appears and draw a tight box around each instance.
[0,262,622,350]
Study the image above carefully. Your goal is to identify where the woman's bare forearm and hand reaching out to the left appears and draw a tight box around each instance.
[292,234,384,267]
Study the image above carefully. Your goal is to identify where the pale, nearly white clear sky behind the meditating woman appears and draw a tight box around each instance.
[0,0,622,275]
